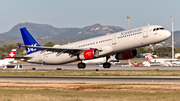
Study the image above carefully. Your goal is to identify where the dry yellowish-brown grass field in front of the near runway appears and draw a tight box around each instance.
[0,84,180,101]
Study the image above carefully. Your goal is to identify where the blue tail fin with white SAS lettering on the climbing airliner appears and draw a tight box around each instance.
[20,27,40,54]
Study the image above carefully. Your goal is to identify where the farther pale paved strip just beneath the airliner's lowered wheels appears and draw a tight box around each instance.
[3,64,180,71]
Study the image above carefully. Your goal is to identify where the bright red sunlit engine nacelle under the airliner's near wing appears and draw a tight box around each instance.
[78,48,99,60]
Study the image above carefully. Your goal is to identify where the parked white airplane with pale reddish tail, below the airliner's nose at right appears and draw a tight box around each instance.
[145,53,178,62]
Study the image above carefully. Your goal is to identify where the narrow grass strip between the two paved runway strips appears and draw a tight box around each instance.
[0,70,180,76]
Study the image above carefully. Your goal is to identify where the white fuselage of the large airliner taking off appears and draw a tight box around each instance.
[26,25,171,64]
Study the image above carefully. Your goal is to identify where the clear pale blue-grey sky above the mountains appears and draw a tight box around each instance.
[0,0,180,33]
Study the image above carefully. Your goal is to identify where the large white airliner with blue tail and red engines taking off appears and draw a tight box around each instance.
[17,25,171,69]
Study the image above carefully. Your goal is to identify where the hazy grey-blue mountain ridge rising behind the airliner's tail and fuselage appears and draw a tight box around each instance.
[0,22,124,45]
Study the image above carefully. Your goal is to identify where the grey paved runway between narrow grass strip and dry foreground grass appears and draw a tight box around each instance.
[0,76,180,85]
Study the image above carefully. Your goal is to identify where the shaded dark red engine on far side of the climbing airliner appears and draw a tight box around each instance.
[116,49,137,60]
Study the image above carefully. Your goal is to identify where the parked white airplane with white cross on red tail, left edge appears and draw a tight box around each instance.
[0,49,17,66]
